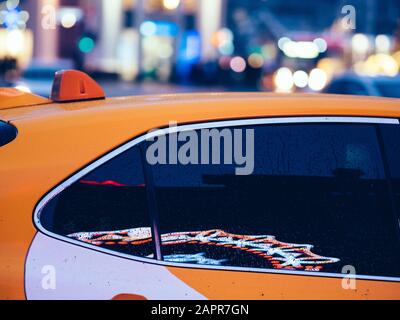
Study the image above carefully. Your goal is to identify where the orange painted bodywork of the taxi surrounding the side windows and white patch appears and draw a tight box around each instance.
[0,87,400,299]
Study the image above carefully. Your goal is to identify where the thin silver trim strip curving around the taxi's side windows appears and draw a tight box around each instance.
[33,116,400,282]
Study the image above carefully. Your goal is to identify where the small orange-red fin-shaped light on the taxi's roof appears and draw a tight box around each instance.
[50,70,105,102]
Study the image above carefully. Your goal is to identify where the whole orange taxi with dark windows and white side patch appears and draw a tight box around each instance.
[0,71,400,299]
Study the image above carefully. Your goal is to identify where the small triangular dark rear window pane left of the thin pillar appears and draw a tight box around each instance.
[41,148,153,257]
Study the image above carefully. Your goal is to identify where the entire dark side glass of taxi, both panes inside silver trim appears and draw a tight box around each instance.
[40,119,400,277]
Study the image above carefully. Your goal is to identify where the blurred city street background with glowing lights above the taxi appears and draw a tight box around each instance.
[0,0,400,97]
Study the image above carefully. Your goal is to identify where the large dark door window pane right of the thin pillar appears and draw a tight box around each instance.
[152,124,400,276]
